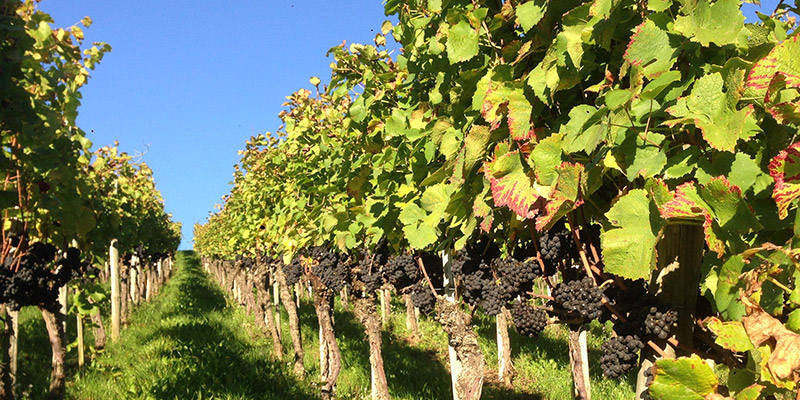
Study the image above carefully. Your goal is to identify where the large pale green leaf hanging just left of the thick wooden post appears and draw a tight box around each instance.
[600,189,665,279]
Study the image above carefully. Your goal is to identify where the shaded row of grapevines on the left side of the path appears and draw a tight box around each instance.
[0,0,180,399]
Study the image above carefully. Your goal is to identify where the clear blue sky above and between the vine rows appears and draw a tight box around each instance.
[39,0,777,249]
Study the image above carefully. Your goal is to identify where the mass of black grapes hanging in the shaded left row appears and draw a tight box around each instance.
[0,242,87,311]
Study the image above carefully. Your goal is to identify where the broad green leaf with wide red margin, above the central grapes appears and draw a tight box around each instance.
[484,143,539,218]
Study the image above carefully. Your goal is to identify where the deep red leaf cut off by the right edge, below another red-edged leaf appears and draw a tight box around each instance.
[769,142,800,219]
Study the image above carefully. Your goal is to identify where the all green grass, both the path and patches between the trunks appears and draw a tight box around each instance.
[19,252,633,400]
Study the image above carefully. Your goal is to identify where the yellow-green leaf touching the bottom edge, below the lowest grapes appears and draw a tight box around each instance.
[649,354,719,400]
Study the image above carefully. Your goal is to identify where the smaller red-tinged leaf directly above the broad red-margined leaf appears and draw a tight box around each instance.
[481,82,533,140]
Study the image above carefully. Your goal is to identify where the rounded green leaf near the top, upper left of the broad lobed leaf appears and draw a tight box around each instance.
[624,20,678,79]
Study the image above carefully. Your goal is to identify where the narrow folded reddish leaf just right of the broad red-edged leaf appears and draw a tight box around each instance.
[536,162,586,231]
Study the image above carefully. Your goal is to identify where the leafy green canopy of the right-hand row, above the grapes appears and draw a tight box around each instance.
[195,0,800,396]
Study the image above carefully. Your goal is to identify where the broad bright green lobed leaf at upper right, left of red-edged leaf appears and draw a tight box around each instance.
[667,72,755,152]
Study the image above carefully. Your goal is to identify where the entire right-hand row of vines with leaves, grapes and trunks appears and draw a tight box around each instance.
[195,0,800,399]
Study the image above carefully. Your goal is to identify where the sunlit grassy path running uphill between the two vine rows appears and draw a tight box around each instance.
[67,252,316,400]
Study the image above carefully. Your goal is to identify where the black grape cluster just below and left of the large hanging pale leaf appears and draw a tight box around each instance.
[553,276,603,320]
